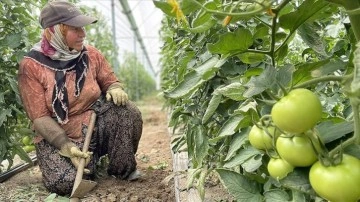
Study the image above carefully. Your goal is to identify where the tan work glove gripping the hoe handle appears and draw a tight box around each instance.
[59,141,92,174]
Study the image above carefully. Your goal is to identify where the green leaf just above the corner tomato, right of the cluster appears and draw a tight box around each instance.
[316,121,354,143]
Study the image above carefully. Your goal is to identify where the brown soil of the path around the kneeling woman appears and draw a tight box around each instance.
[0,96,175,202]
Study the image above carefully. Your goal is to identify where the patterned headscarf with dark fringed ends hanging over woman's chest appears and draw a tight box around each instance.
[25,24,89,124]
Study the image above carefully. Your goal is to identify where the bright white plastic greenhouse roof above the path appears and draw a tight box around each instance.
[78,0,163,80]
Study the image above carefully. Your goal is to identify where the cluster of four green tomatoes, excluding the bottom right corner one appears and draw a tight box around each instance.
[249,88,322,179]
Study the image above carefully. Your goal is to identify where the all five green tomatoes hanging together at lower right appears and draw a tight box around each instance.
[248,88,360,202]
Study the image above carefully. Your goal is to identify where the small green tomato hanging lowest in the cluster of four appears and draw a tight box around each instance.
[267,158,294,180]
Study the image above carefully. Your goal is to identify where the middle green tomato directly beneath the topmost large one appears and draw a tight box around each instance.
[276,135,317,167]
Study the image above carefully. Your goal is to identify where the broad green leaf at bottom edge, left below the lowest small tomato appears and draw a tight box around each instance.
[216,169,263,202]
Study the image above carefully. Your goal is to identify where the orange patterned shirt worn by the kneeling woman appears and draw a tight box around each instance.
[18,46,118,142]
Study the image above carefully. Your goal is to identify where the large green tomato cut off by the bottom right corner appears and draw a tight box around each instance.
[309,154,360,202]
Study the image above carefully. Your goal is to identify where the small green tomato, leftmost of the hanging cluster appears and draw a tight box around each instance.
[248,125,275,150]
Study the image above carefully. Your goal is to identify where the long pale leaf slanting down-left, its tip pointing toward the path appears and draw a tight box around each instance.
[165,56,219,99]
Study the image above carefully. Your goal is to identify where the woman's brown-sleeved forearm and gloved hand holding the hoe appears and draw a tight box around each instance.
[33,116,92,173]
